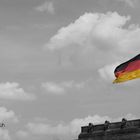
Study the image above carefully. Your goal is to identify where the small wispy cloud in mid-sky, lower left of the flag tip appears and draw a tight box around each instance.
[41,80,85,95]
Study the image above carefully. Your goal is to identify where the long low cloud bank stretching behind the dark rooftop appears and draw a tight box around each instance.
[26,114,136,139]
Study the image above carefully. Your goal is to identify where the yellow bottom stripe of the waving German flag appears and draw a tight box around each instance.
[113,69,140,83]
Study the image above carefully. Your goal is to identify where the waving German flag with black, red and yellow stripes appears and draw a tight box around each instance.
[113,54,140,83]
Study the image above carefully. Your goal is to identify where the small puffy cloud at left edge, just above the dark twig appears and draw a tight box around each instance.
[0,107,18,123]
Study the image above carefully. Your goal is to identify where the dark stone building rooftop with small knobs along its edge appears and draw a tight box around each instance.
[78,118,140,140]
